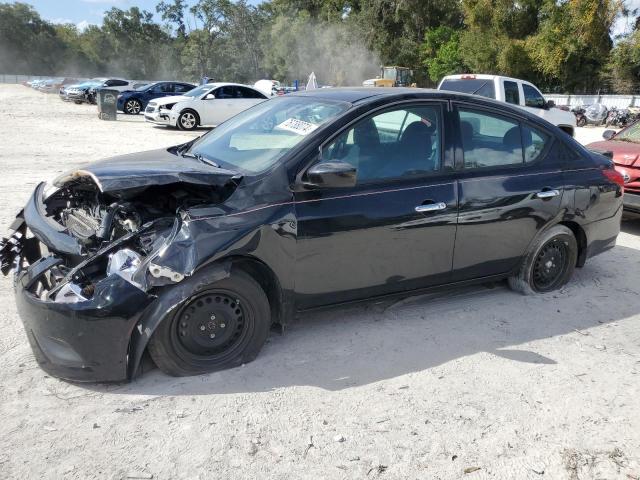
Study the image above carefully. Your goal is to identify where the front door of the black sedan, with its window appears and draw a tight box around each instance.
[295,103,457,308]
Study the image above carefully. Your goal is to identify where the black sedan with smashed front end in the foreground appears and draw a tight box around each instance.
[0,88,623,381]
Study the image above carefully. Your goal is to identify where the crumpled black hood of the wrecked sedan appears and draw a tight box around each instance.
[53,149,242,193]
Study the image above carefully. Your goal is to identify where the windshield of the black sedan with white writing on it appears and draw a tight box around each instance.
[189,96,351,174]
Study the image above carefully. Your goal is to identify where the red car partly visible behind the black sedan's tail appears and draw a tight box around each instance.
[587,121,640,213]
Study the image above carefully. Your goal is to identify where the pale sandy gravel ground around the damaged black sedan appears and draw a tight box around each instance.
[0,85,640,480]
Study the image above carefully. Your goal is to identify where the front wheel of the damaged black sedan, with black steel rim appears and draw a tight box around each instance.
[149,271,271,377]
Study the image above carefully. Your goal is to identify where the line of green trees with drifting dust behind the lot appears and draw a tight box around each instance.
[0,0,640,93]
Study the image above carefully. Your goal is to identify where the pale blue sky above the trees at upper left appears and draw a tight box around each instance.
[11,0,262,28]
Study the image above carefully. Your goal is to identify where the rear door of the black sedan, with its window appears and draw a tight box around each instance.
[453,103,563,281]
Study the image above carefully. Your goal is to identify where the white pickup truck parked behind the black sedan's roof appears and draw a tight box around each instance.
[438,74,576,136]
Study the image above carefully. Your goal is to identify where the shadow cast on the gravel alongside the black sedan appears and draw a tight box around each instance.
[85,221,640,395]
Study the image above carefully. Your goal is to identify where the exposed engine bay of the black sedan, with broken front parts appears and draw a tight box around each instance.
[1,172,237,303]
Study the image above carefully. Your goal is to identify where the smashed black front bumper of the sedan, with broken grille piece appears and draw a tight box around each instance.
[0,213,154,381]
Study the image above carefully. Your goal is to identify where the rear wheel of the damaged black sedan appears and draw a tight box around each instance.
[509,225,578,295]
